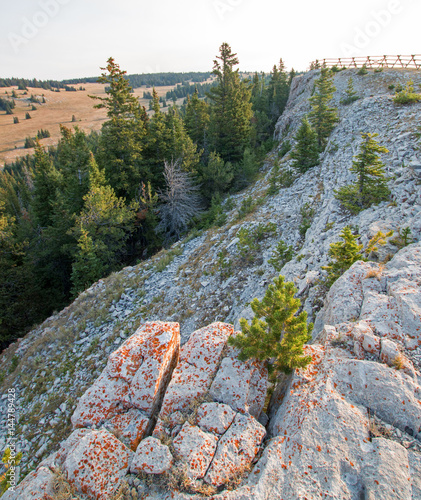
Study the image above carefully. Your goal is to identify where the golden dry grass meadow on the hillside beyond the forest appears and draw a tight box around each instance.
[0,83,182,168]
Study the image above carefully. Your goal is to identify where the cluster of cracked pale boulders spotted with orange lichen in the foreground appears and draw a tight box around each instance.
[5,322,267,500]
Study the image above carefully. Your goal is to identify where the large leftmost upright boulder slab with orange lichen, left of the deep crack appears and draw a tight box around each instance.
[72,321,180,430]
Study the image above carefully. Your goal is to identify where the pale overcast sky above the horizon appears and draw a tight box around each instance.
[0,0,421,80]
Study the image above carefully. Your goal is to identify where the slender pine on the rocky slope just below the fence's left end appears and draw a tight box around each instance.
[309,68,338,151]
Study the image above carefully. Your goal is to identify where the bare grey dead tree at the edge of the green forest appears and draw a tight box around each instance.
[156,160,201,244]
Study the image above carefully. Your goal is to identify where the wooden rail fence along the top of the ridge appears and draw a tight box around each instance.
[310,54,421,69]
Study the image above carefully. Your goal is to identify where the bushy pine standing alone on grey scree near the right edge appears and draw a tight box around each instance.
[335,133,390,214]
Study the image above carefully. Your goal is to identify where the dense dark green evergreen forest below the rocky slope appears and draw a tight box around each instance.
[0,43,291,347]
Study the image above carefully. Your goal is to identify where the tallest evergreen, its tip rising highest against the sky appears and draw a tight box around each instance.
[208,43,252,162]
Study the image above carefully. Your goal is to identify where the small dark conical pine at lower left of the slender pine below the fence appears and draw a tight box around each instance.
[290,116,319,173]
